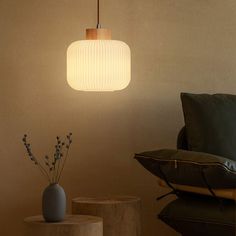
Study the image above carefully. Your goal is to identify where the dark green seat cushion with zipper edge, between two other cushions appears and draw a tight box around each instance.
[135,149,236,188]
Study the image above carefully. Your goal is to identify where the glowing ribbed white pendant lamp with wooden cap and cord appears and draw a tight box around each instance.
[67,0,131,91]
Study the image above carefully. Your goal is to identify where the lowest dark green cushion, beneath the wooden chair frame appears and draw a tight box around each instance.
[159,195,236,236]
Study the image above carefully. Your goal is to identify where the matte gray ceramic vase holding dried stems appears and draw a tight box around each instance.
[42,184,66,222]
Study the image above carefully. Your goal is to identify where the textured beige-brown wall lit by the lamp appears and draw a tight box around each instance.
[0,0,236,236]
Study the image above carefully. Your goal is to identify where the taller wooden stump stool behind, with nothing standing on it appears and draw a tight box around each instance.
[72,196,141,236]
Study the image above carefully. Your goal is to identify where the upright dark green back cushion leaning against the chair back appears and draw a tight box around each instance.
[181,93,236,160]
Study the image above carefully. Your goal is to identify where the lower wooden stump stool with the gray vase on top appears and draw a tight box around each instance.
[24,215,103,236]
